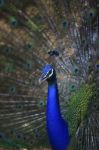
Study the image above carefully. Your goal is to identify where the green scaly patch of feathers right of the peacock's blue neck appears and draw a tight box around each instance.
[67,84,93,135]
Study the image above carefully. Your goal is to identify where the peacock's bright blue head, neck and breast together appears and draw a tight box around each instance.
[41,65,69,150]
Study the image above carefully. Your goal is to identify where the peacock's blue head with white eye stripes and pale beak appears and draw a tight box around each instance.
[39,64,56,83]
